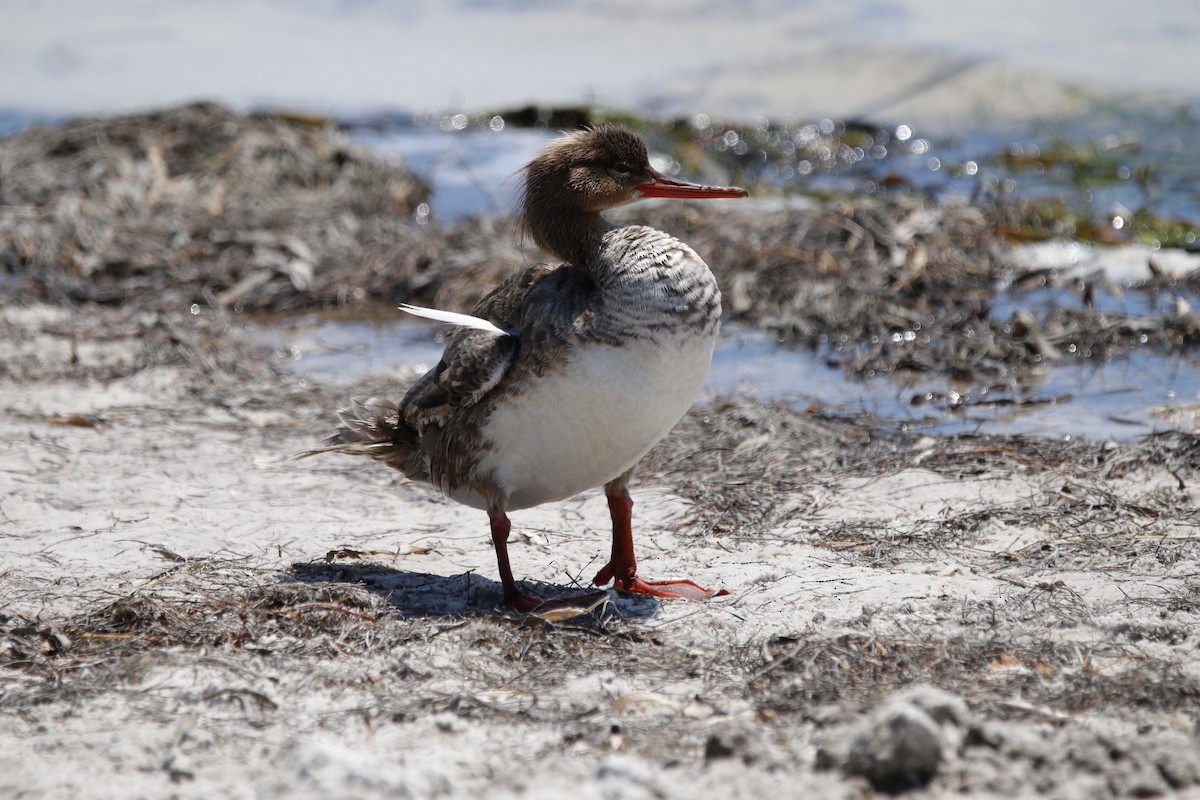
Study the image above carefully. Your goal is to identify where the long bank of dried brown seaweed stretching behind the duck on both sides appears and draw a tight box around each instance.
[0,104,1200,393]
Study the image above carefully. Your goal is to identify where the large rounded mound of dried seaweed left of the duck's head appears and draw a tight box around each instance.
[0,103,428,311]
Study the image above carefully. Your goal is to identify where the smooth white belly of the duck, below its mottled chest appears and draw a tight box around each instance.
[455,332,715,510]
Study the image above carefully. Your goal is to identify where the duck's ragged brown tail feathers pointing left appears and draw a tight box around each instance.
[295,397,428,480]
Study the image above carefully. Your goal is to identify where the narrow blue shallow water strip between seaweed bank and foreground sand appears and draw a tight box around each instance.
[247,311,1200,439]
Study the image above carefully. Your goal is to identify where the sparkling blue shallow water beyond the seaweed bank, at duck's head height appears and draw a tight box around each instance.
[348,104,1200,237]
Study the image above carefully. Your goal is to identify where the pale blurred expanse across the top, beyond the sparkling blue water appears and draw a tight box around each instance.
[0,0,1200,125]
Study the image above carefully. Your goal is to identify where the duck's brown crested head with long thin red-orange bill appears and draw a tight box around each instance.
[521,125,746,263]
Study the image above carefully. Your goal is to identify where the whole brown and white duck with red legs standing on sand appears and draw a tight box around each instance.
[319,126,746,613]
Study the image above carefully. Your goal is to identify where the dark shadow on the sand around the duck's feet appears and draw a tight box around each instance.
[282,560,659,622]
